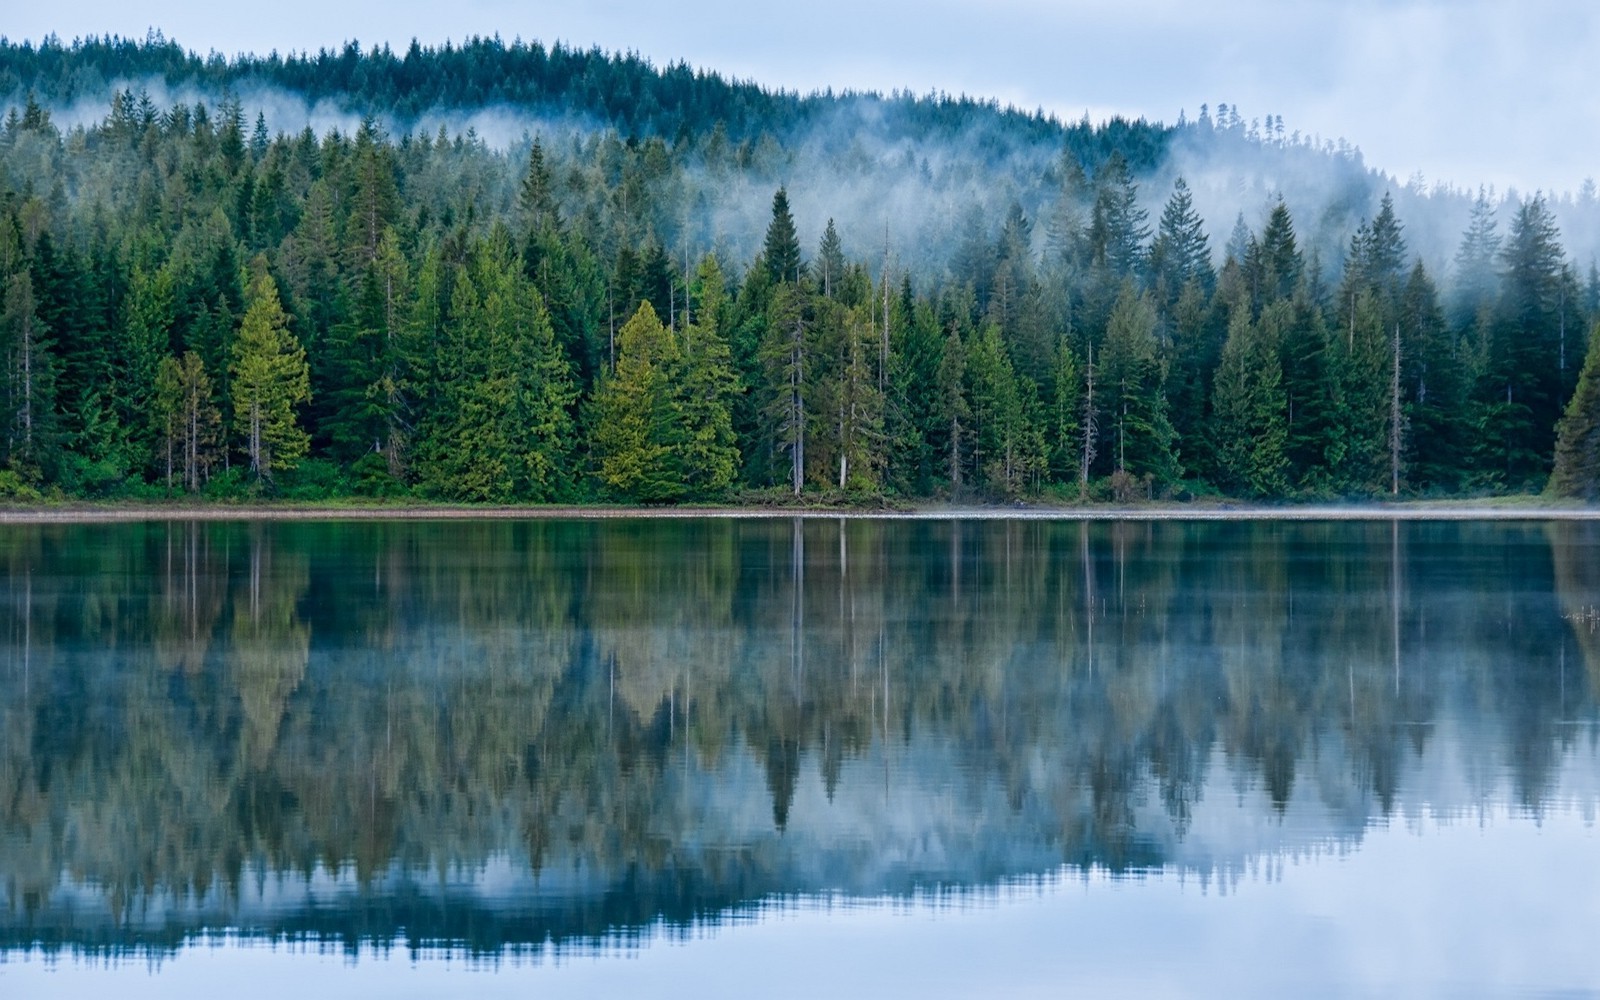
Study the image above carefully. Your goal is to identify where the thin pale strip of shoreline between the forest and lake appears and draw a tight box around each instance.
[0,499,1600,525]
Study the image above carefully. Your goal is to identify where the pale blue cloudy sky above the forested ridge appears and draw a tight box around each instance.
[0,0,1600,192]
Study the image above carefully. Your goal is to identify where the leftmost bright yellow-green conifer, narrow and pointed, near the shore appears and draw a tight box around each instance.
[229,258,310,482]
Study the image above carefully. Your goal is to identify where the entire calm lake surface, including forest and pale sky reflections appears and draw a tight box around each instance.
[0,518,1600,998]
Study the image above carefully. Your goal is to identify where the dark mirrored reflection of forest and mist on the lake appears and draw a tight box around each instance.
[0,518,1600,954]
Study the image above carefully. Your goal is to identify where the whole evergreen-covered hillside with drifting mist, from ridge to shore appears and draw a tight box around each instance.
[0,37,1600,502]
